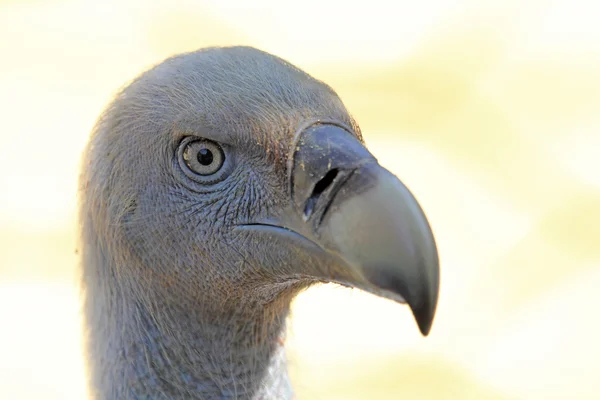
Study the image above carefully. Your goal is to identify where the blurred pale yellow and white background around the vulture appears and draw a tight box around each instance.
[0,0,600,400]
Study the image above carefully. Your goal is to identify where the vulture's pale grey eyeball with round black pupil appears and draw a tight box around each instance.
[182,139,225,176]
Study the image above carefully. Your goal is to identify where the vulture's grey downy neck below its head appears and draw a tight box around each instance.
[84,245,292,400]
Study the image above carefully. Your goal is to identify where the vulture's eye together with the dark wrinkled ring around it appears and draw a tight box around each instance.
[176,136,233,185]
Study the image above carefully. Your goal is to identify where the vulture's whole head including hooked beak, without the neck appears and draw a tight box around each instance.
[82,47,439,334]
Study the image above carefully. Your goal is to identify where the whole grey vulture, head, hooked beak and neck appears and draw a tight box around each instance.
[79,46,439,400]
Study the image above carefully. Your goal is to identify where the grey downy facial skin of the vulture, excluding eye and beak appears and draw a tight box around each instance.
[82,48,360,316]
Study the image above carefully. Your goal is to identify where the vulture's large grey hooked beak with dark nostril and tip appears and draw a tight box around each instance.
[239,124,439,335]
